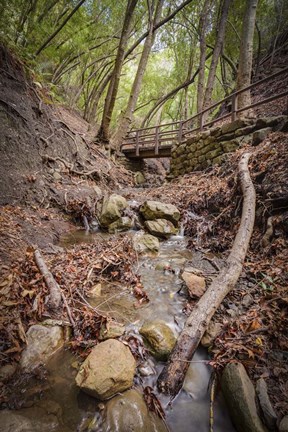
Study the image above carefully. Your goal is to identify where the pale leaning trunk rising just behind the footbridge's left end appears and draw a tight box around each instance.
[112,0,164,149]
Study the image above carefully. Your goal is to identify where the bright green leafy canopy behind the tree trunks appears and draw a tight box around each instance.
[0,0,288,131]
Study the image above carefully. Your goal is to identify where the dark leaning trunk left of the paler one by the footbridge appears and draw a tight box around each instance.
[98,0,137,141]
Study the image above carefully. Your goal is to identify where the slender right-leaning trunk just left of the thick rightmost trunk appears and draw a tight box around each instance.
[203,0,231,120]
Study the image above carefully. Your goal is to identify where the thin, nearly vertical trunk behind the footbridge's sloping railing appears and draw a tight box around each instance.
[197,0,210,112]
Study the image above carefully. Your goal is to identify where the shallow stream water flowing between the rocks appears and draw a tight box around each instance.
[7,231,234,432]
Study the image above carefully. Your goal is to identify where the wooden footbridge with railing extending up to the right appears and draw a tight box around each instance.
[121,67,288,159]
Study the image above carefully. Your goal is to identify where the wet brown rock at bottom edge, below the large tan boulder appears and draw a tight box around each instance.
[103,390,167,432]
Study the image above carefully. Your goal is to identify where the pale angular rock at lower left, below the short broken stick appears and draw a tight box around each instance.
[20,324,64,371]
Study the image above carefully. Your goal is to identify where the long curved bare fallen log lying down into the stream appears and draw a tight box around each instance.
[157,153,256,397]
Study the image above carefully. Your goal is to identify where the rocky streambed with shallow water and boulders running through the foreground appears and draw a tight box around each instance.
[0,195,275,432]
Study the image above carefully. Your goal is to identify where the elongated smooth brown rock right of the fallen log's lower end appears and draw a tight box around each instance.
[221,363,267,432]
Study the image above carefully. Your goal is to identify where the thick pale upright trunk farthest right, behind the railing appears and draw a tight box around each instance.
[236,0,258,117]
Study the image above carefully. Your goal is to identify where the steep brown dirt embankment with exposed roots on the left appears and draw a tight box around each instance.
[0,46,133,262]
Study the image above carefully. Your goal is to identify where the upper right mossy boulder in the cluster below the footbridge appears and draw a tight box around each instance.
[140,201,180,226]
